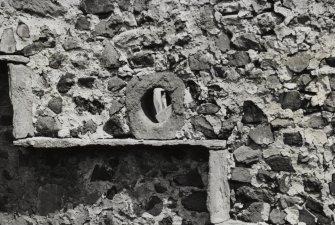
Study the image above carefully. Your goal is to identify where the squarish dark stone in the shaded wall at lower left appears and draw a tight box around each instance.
[37,184,64,216]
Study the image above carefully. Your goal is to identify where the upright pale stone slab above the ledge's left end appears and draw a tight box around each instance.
[8,64,34,139]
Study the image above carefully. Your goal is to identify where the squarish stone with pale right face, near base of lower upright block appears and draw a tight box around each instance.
[242,202,270,223]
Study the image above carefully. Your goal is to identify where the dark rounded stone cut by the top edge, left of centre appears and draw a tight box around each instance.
[80,0,114,15]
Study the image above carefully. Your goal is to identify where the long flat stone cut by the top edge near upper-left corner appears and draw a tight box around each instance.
[10,0,66,16]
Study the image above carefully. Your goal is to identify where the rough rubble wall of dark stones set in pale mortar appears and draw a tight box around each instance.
[0,0,335,225]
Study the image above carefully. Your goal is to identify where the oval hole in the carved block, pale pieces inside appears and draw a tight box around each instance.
[141,88,172,123]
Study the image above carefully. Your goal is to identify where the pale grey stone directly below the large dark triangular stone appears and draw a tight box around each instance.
[249,125,274,145]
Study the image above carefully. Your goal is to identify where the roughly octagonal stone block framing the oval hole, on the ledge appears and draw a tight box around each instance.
[126,72,185,139]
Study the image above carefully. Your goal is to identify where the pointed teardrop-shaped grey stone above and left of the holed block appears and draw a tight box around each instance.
[101,42,121,69]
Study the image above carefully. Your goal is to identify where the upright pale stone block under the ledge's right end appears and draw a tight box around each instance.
[207,150,230,224]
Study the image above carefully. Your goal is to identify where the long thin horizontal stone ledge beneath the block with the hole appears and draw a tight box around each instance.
[13,137,226,150]
